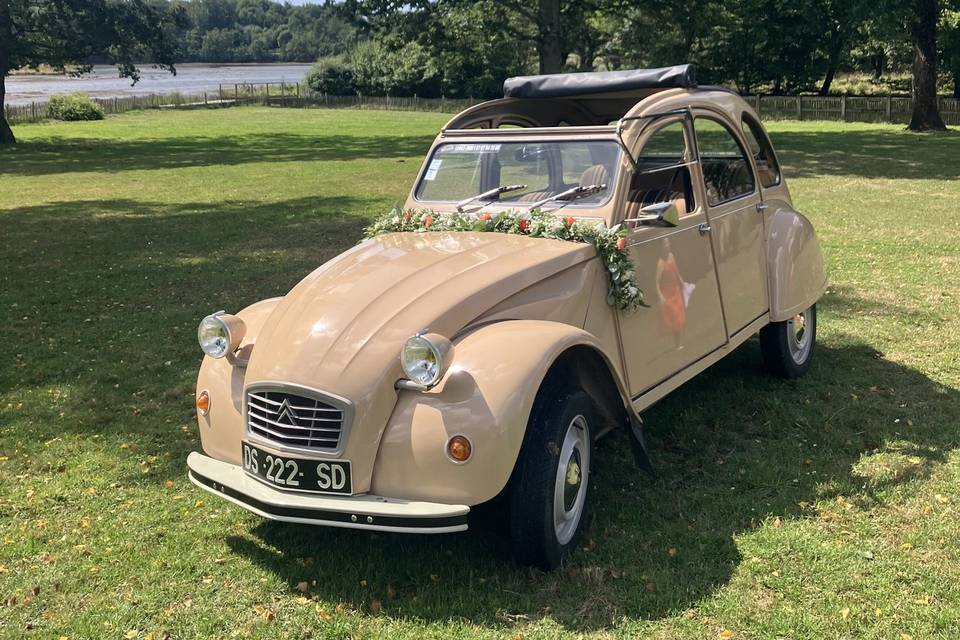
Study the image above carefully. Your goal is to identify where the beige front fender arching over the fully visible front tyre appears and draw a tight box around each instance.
[371,320,622,505]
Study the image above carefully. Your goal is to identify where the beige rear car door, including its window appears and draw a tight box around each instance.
[694,112,769,336]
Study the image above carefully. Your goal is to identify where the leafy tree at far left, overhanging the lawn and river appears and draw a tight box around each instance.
[0,0,185,144]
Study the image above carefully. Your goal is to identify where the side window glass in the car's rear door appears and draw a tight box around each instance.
[695,117,756,206]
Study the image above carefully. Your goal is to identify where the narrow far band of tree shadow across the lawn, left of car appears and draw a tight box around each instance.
[0,133,433,176]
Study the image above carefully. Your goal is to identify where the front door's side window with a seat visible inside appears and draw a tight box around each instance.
[626,121,696,218]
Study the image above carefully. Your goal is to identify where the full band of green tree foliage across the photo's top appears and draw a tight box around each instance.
[0,0,960,138]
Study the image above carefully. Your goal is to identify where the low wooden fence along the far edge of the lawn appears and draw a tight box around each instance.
[4,82,960,125]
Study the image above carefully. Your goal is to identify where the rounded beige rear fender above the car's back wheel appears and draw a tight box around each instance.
[766,204,827,322]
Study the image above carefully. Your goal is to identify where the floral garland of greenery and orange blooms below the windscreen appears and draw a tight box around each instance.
[365,209,646,311]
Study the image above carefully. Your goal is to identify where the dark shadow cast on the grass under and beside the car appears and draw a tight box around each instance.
[227,336,960,631]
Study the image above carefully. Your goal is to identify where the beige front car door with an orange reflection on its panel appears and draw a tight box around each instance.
[618,119,726,397]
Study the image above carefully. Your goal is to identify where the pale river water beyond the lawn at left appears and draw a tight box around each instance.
[7,64,310,104]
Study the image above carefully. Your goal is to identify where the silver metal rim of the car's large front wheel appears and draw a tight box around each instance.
[553,416,590,544]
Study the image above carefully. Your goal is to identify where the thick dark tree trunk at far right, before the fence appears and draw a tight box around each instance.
[907,0,947,131]
